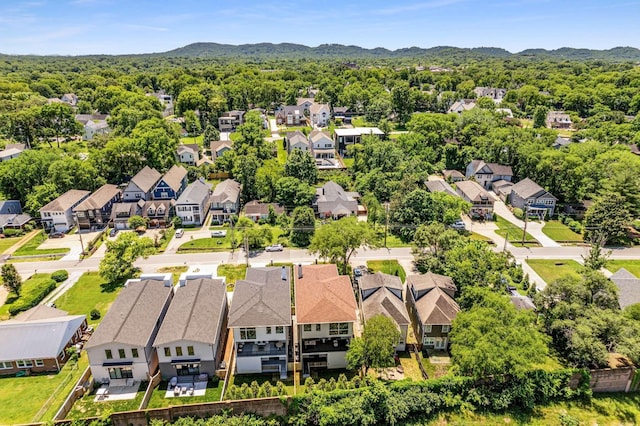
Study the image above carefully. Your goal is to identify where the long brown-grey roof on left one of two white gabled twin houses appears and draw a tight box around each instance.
[85,279,173,349]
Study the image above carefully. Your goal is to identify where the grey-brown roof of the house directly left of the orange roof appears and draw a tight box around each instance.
[228,266,291,328]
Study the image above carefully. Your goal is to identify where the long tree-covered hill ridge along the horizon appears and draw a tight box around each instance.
[159,43,640,61]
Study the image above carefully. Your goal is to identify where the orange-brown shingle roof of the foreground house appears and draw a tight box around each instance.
[295,264,357,324]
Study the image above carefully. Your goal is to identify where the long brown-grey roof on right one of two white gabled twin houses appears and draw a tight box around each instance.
[153,278,227,346]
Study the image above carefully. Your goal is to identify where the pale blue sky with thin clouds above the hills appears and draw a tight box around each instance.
[0,0,640,55]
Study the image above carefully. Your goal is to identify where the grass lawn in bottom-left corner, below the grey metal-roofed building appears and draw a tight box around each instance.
[0,353,89,424]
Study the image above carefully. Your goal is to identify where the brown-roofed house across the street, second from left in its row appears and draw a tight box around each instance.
[72,183,122,229]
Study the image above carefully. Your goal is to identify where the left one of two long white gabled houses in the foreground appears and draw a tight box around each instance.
[85,274,177,384]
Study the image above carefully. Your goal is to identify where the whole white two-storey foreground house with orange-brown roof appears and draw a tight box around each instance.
[294,264,358,376]
